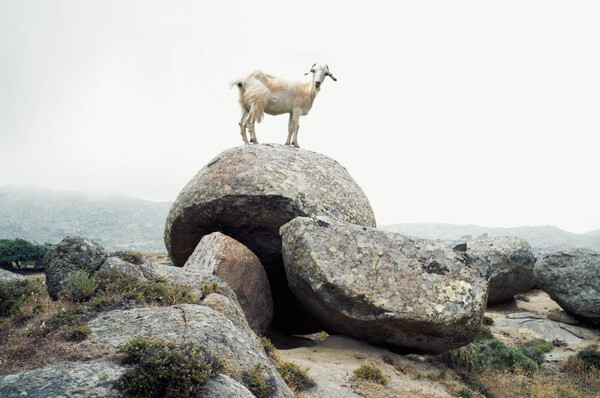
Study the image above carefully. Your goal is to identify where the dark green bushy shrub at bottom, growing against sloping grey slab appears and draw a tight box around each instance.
[116,337,223,397]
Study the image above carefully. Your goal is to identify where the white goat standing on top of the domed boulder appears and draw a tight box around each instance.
[231,62,337,148]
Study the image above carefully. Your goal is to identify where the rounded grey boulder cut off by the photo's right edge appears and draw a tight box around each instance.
[534,249,600,325]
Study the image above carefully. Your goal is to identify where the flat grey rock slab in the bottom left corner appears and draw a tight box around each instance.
[0,360,125,398]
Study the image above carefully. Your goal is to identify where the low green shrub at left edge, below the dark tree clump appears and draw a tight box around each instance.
[0,279,46,318]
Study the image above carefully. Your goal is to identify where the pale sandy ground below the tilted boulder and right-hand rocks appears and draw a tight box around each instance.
[271,289,600,398]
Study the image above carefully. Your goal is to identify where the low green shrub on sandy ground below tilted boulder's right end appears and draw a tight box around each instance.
[450,339,537,373]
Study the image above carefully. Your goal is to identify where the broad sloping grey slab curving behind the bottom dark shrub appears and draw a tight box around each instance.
[88,304,293,398]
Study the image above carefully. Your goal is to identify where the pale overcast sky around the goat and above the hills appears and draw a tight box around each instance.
[0,0,600,232]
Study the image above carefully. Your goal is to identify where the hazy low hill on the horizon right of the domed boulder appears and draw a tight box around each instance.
[380,223,600,257]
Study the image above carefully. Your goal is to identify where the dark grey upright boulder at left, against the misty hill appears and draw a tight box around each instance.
[43,236,107,300]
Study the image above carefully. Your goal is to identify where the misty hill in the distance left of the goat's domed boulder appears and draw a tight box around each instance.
[0,186,172,252]
